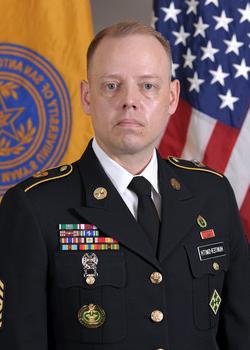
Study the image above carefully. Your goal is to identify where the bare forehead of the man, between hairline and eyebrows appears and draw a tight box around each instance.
[89,34,170,77]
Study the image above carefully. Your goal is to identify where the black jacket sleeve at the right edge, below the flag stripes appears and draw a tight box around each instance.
[218,180,250,350]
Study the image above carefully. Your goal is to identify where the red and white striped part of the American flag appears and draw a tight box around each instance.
[159,100,250,241]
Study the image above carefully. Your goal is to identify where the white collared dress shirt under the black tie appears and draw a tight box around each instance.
[92,139,161,219]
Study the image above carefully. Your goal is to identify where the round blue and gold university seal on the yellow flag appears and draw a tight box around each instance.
[0,44,72,196]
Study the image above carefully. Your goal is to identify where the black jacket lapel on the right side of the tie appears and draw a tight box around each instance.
[158,157,202,262]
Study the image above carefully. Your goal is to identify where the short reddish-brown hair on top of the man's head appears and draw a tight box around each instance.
[87,21,172,77]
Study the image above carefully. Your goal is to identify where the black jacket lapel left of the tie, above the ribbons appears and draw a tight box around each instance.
[73,144,160,269]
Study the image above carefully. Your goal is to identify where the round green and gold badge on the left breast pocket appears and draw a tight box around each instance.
[78,304,106,328]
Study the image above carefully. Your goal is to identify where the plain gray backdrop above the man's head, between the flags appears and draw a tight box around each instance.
[90,0,153,33]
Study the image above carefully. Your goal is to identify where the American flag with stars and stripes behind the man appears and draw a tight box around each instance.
[154,0,250,240]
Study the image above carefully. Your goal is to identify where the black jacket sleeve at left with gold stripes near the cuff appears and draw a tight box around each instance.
[0,188,48,350]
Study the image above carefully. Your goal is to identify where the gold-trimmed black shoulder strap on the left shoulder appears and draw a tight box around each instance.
[24,164,73,192]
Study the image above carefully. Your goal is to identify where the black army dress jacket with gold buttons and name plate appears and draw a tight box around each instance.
[0,140,250,350]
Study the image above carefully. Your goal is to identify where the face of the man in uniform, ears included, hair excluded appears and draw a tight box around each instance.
[81,35,179,159]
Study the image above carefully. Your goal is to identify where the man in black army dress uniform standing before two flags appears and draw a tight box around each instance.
[0,23,250,350]
